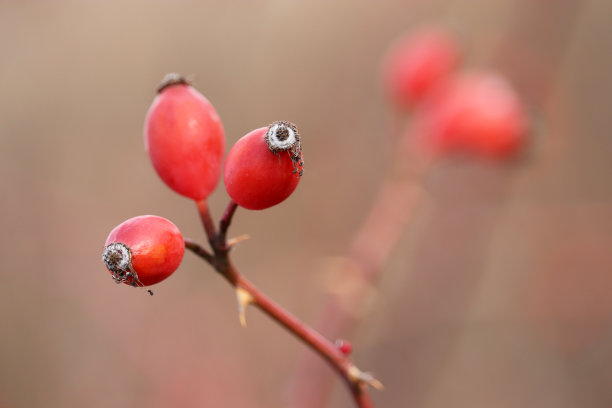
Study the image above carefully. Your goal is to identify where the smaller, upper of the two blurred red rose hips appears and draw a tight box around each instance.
[383,27,460,109]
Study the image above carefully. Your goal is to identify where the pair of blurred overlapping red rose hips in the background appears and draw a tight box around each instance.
[383,26,528,159]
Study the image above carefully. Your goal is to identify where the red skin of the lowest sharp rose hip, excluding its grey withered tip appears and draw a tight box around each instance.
[105,215,185,286]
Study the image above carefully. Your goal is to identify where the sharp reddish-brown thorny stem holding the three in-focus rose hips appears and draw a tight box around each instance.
[185,201,380,408]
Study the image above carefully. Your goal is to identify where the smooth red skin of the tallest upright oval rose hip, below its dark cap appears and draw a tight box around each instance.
[144,76,225,201]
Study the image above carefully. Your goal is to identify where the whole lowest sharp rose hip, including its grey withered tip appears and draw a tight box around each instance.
[102,215,185,286]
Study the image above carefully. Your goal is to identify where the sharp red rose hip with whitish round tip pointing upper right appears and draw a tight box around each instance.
[223,122,304,210]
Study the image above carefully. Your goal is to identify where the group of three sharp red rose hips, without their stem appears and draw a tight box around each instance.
[102,74,304,293]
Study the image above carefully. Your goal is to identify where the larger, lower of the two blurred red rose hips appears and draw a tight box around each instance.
[414,71,528,158]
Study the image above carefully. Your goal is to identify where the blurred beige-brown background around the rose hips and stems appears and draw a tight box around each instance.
[0,0,612,408]
